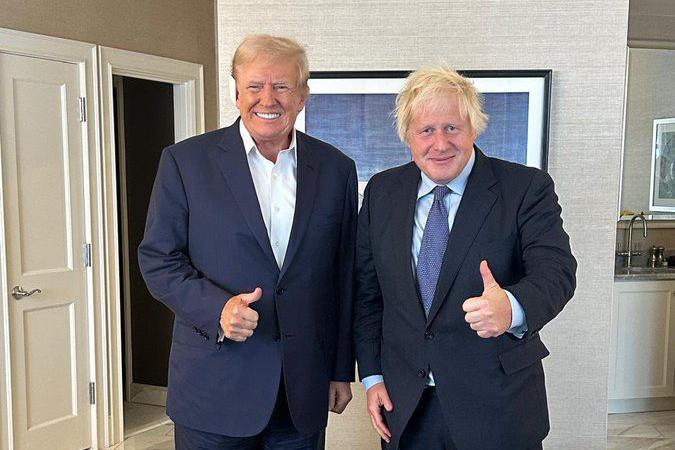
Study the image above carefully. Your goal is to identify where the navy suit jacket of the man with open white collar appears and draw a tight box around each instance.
[139,121,357,436]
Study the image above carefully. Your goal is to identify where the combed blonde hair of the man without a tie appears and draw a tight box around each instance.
[231,34,309,94]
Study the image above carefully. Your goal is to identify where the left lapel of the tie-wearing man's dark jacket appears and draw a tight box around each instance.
[390,162,424,317]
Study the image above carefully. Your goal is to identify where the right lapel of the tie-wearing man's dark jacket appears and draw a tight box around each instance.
[427,147,497,324]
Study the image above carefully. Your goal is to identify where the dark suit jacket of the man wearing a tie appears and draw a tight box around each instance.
[354,149,576,450]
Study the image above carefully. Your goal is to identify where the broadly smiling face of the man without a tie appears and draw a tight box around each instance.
[237,58,306,152]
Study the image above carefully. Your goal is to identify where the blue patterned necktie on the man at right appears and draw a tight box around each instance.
[417,186,450,316]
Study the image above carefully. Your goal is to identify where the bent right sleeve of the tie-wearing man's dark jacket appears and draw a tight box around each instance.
[504,171,577,336]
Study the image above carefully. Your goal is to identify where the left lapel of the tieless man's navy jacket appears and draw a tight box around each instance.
[211,120,278,270]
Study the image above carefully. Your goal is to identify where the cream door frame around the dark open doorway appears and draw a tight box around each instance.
[97,46,204,446]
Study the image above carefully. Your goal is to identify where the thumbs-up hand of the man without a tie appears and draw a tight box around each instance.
[220,287,262,342]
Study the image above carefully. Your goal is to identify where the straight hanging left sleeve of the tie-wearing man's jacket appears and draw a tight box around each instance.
[354,179,383,379]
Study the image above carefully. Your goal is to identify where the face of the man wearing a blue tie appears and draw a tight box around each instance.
[408,94,476,184]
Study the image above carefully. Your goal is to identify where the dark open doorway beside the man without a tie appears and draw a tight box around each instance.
[113,75,175,438]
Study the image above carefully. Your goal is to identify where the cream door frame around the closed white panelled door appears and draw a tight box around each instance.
[0,28,104,450]
